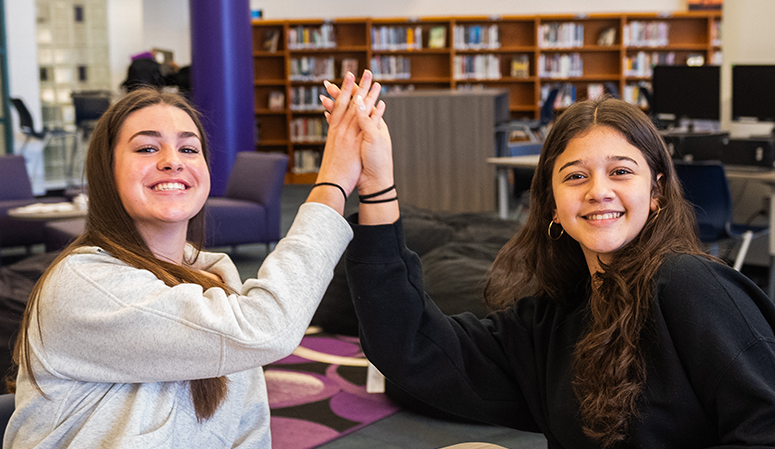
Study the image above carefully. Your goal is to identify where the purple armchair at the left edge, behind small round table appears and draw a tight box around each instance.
[0,156,66,252]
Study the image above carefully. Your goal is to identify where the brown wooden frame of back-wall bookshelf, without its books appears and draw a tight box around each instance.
[253,11,722,183]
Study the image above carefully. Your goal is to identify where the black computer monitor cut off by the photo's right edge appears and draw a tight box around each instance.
[732,65,775,122]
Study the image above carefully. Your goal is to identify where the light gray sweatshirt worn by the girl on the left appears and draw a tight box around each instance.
[3,203,352,449]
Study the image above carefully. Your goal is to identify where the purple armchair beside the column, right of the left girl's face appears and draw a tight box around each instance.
[205,151,288,248]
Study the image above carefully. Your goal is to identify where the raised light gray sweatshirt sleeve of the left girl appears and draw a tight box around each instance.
[30,203,352,382]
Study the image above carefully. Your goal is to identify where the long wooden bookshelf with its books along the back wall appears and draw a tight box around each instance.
[253,11,722,183]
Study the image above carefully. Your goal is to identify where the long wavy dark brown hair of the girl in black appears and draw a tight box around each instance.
[485,98,704,447]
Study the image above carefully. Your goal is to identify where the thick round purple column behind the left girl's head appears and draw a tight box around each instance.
[190,0,256,196]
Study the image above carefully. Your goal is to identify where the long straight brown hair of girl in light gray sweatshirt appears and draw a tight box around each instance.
[14,88,231,422]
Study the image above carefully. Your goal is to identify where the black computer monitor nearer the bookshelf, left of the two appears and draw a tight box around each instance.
[651,65,721,122]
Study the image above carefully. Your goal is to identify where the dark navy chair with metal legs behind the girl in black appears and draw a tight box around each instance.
[673,161,769,271]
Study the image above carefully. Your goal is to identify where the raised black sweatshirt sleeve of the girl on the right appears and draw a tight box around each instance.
[346,218,538,431]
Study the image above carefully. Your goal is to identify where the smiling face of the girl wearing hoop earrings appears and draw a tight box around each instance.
[552,126,658,273]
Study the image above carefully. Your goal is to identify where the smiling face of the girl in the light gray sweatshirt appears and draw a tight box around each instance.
[114,104,210,240]
